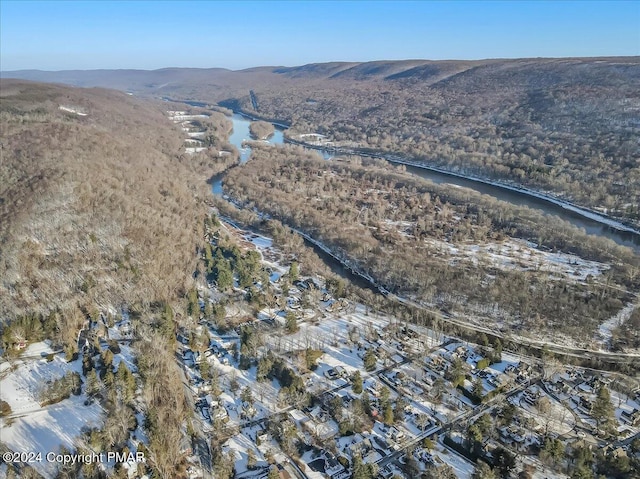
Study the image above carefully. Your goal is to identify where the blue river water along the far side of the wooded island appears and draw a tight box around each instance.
[212,113,640,252]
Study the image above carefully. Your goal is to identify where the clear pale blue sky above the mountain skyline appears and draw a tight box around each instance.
[0,0,640,71]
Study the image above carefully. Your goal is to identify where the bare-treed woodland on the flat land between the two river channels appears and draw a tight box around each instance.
[225,147,640,344]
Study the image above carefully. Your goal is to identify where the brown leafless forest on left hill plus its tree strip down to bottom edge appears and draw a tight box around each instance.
[0,80,226,478]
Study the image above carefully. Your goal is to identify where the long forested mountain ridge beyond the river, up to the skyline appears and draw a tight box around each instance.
[3,57,640,227]
